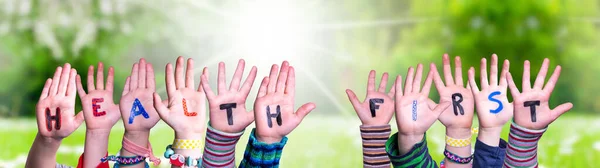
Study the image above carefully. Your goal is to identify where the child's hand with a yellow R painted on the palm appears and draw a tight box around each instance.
[430,54,474,133]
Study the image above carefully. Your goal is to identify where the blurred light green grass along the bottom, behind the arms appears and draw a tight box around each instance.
[0,115,600,167]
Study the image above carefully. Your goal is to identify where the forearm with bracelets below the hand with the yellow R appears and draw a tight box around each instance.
[444,128,471,167]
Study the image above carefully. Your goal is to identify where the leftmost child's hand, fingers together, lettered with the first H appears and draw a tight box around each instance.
[36,63,84,141]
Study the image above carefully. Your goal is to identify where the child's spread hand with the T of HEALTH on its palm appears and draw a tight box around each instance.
[201,59,256,133]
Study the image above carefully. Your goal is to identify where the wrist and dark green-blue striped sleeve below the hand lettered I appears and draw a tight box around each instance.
[385,133,437,168]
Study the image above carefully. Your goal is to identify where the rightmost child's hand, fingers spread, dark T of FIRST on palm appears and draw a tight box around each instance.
[508,58,573,130]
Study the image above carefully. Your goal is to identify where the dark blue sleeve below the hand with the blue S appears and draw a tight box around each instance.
[473,139,507,168]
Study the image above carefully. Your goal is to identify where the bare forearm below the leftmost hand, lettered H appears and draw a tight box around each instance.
[25,133,61,168]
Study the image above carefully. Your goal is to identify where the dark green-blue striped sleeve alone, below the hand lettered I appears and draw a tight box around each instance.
[385,133,437,168]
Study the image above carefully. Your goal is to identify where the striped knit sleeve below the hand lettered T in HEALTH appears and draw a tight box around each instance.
[202,124,244,168]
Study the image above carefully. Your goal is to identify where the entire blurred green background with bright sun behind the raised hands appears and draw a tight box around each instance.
[0,0,600,167]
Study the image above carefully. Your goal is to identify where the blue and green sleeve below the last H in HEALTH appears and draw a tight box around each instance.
[240,129,287,168]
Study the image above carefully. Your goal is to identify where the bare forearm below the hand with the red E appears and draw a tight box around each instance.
[83,129,110,167]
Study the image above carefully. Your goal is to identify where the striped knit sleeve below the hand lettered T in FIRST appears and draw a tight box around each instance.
[504,122,546,167]
